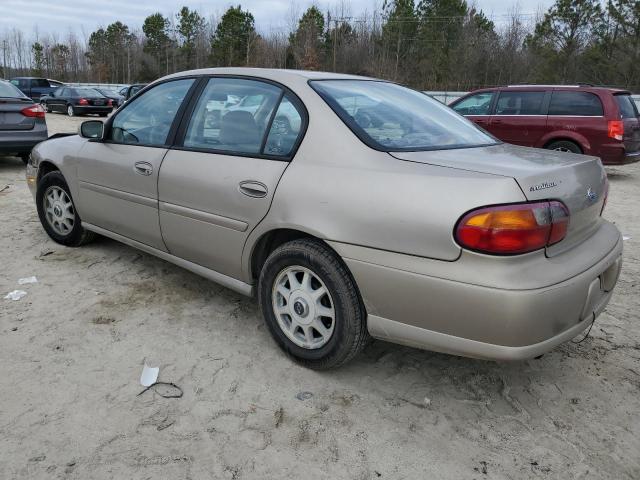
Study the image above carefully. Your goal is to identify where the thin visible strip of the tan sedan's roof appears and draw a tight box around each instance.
[164,67,372,83]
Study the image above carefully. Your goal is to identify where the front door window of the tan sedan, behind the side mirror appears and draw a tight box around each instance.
[109,78,194,146]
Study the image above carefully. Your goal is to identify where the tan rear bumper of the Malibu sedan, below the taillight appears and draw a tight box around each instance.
[334,223,622,360]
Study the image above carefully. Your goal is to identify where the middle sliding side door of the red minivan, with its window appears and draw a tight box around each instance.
[487,89,549,147]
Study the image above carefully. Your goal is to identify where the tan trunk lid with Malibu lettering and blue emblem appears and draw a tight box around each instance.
[391,144,607,256]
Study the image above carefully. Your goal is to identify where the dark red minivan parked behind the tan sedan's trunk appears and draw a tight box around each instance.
[450,85,640,165]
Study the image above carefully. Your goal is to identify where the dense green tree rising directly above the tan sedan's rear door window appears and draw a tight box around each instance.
[211,5,257,67]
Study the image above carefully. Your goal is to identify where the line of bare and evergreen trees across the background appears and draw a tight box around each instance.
[0,0,640,92]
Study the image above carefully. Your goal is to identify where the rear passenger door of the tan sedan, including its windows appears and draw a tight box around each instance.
[158,77,303,278]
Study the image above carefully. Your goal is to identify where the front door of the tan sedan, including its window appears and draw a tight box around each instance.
[78,78,195,251]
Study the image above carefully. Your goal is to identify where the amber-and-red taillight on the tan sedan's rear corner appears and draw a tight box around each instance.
[455,201,569,255]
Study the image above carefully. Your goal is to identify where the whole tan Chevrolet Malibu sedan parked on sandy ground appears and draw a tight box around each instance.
[27,68,622,368]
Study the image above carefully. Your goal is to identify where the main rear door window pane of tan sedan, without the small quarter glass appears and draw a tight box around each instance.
[183,78,282,155]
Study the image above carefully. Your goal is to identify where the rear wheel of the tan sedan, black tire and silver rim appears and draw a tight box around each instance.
[258,239,369,369]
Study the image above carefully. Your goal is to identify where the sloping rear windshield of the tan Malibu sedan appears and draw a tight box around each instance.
[311,80,499,151]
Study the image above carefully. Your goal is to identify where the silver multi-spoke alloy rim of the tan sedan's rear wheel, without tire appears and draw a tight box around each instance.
[271,266,336,349]
